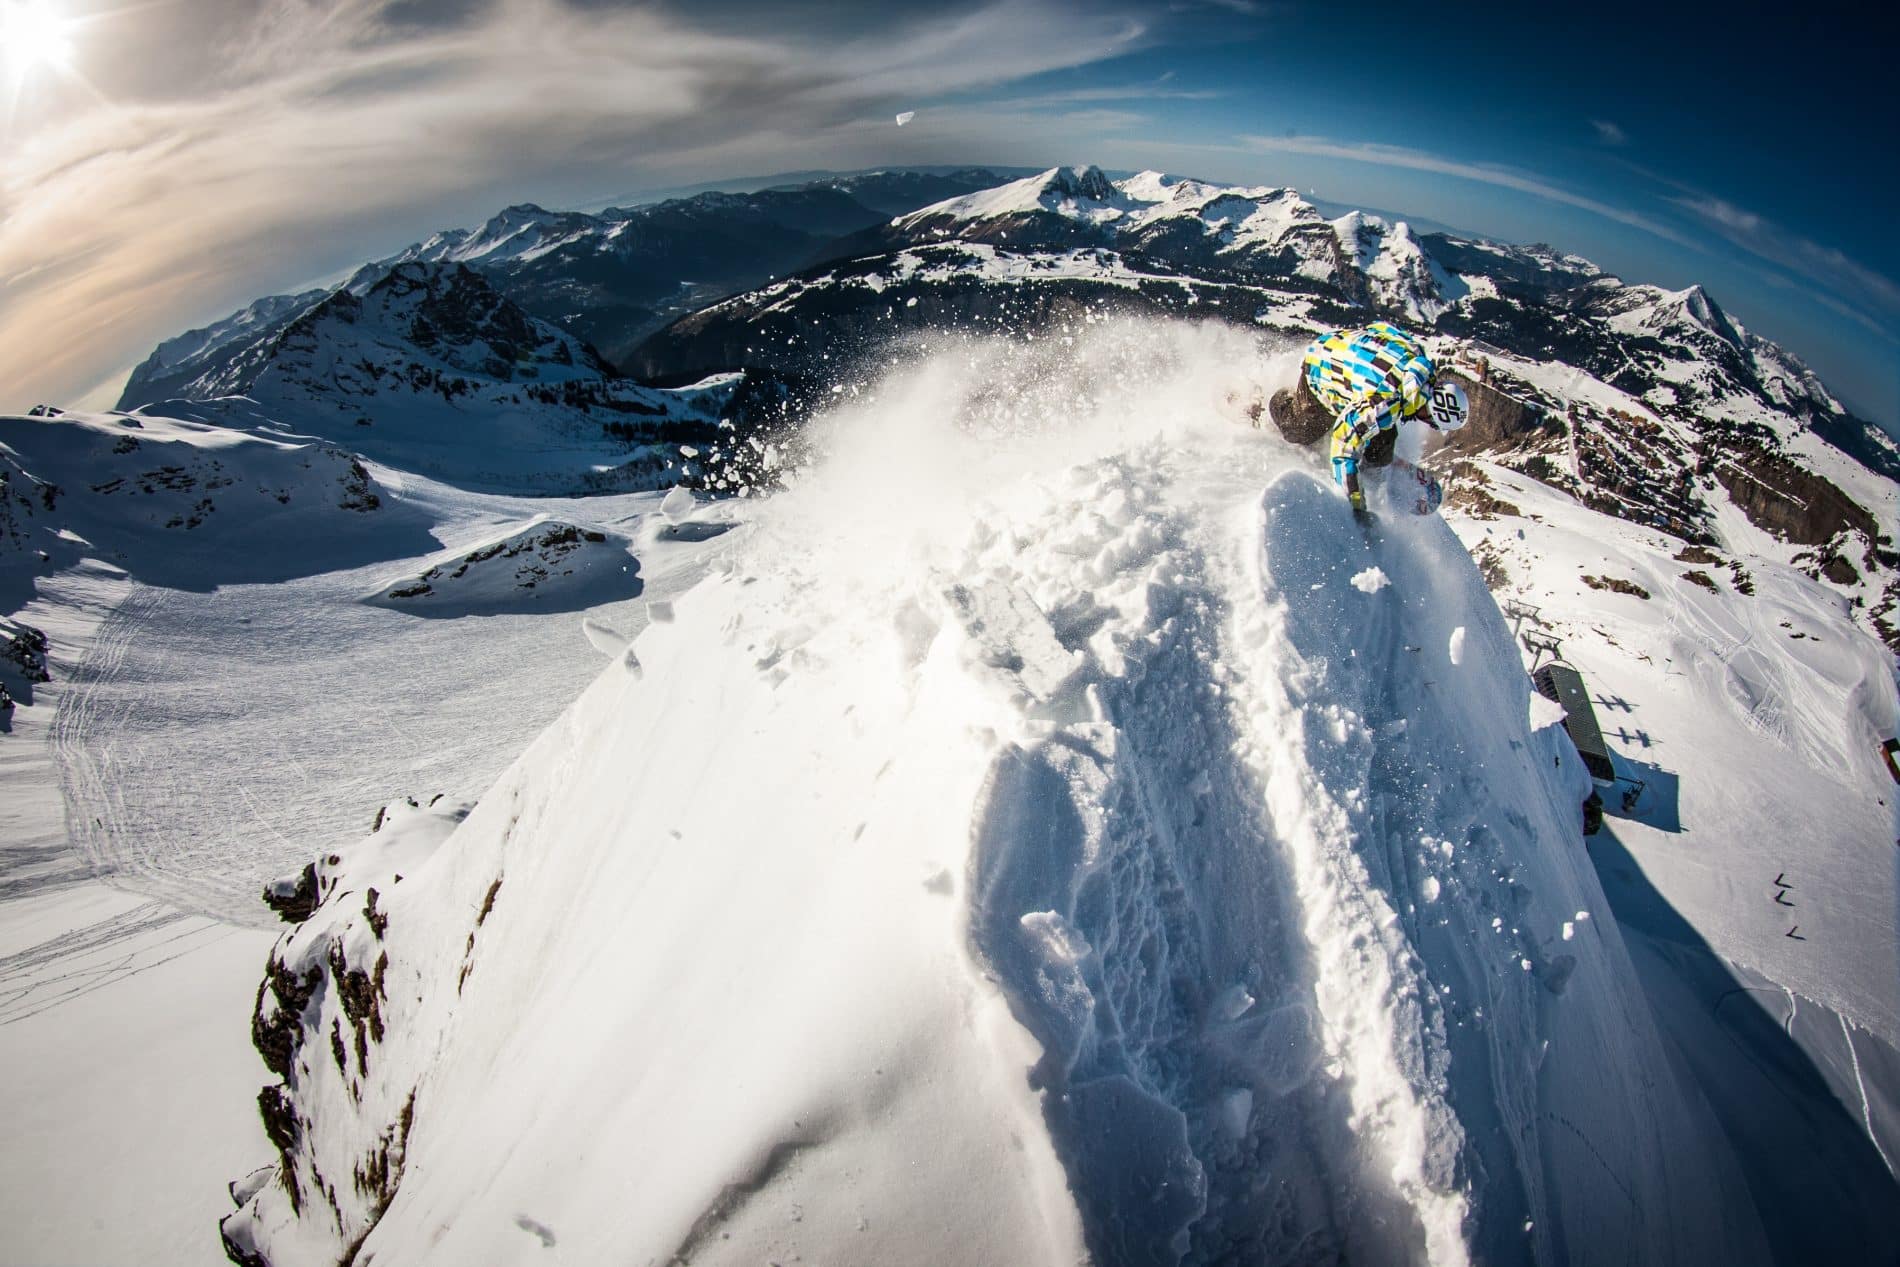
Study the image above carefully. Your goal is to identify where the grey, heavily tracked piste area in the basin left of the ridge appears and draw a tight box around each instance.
[51,477,725,929]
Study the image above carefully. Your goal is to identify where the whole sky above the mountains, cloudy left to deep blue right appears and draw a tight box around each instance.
[0,0,1900,425]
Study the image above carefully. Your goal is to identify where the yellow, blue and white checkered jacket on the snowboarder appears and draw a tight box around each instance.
[1305,321,1436,486]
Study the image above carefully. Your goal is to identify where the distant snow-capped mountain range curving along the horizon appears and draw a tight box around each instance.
[120,167,1900,646]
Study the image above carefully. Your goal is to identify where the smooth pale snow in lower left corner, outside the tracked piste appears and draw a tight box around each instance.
[0,564,272,1267]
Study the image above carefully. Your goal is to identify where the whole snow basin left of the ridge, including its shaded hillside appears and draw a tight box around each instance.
[0,433,730,1267]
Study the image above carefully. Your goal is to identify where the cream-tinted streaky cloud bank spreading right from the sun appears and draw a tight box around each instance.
[0,0,1144,405]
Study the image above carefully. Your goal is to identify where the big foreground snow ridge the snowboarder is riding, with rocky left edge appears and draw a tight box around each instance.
[226,325,1769,1267]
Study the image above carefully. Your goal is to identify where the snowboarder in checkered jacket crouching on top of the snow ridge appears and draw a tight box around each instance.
[1267,321,1471,515]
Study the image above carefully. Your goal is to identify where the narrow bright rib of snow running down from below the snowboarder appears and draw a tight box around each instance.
[1233,475,1471,1263]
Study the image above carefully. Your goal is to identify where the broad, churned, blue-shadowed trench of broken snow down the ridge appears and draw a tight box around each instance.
[971,446,1467,1263]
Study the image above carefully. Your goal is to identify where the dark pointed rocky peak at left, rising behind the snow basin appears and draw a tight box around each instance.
[109,260,741,490]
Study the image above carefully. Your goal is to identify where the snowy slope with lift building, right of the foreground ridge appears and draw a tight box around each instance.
[1457,455,1900,1261]
